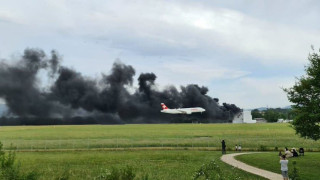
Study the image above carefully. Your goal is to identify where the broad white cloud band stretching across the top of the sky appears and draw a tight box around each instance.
[1,0,320,64]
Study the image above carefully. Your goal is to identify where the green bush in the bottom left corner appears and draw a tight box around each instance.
[0,142,38,180]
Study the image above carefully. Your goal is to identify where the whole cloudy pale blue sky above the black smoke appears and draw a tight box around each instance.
[0,0,320,109]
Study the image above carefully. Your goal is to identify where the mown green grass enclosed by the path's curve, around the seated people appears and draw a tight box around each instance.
[236,152,320,180]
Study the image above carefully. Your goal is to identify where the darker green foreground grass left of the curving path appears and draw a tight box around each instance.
[17,150,263,180]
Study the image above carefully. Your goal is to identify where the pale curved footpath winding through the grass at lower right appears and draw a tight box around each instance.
[221,152,283,180]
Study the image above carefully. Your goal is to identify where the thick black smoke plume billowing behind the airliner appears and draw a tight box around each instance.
[0,49,240,124]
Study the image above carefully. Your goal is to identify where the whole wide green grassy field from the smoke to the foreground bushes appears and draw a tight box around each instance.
[0,124,320,179]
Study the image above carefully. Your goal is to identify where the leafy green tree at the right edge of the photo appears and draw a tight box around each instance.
[284,48,320,140]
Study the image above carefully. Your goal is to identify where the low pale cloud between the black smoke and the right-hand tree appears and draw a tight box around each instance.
[212,77,295,109]
